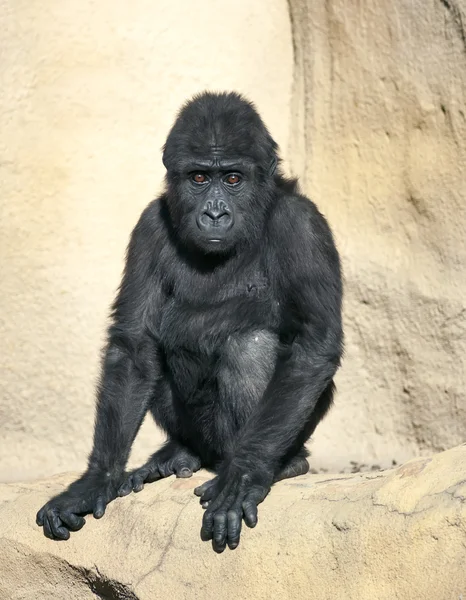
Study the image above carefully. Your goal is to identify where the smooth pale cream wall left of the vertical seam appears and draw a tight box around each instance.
[0,0,292,481]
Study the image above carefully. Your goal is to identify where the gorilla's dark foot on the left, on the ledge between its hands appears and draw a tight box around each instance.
[118,440,201,496]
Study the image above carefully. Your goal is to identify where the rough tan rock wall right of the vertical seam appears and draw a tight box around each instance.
[290,0,466,468]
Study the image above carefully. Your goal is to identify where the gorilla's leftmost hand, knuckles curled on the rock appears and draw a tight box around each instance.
[36,472,121,540]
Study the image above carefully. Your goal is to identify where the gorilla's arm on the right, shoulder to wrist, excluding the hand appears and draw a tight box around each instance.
[233,200,343,471]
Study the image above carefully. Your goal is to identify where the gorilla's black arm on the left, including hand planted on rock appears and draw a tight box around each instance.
[37,206,160,539]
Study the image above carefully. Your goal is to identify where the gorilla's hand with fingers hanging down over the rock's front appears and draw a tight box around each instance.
[194,467,273,553]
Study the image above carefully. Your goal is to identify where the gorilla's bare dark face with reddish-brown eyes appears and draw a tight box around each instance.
[169,155,263,254]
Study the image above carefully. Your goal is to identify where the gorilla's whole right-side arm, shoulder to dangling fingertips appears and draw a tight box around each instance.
[196,200,342,551]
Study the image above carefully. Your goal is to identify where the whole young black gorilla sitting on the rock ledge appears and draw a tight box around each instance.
[37,93,342,552]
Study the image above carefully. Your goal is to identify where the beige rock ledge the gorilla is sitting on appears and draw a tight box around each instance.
[0,446,466,600]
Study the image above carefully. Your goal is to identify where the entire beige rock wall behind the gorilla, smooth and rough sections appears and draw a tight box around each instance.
[0,0,466,481]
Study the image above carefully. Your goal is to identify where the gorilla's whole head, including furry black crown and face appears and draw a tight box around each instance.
[163,92,278,254]
